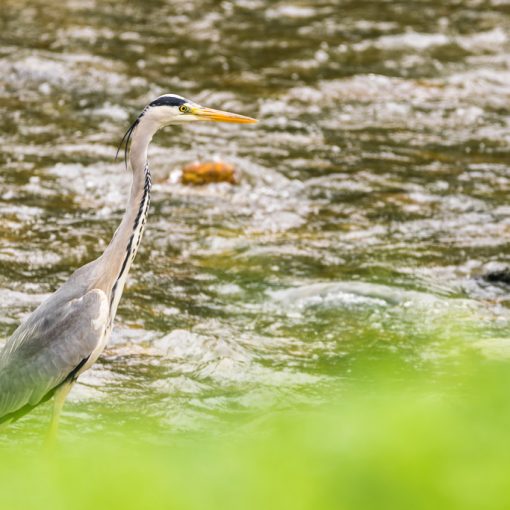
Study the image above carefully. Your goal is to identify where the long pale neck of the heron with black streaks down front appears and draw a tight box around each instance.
[98,123,157,320]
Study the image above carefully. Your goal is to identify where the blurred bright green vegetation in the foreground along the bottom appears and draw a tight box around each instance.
[0,350,510,510]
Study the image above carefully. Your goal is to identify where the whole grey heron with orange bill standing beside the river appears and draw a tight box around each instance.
[0,94,256,437]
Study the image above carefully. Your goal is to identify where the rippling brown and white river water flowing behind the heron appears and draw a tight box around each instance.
[0,0,510,434]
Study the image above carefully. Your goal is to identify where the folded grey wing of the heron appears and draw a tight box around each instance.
[0,289,108,419]
